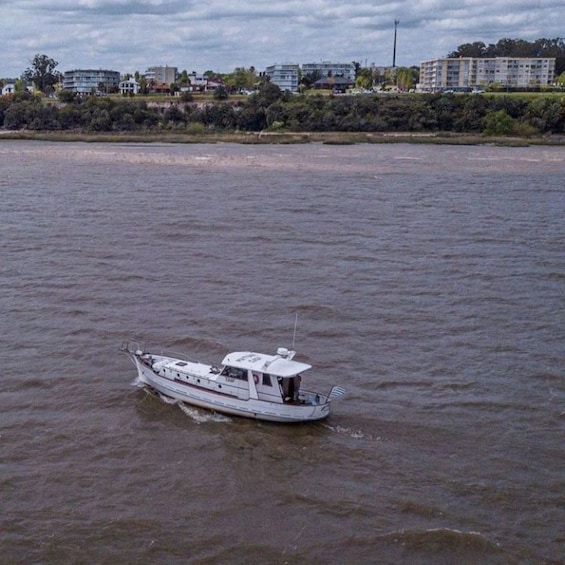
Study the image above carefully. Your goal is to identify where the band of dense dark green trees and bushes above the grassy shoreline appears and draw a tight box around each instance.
[0,83,565,136]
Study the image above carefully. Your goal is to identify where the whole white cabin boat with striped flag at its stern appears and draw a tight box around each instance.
[120,341,345,422]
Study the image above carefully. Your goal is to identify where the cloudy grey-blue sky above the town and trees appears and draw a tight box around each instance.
[0,0,565,78]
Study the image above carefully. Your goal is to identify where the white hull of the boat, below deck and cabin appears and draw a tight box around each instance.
[132,355,330,423]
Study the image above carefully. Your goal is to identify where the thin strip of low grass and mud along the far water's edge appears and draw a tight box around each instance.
[0,130,565,147]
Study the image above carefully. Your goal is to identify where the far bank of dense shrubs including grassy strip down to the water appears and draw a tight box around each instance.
[0,84,565,145]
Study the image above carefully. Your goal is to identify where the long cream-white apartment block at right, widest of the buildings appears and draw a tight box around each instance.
[420,57,555,92]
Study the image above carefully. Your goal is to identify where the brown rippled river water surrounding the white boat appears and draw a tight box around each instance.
[0,140,565,564]
